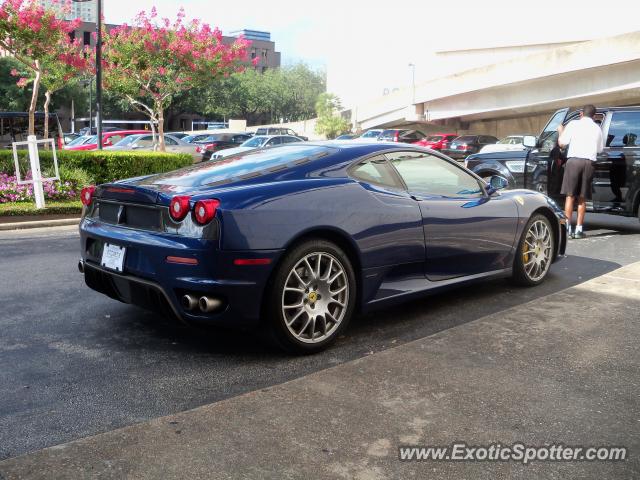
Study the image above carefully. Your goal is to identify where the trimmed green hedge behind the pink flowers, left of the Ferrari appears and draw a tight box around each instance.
[0,149,193,184]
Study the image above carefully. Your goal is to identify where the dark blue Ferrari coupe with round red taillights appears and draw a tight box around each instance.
[79,142,566,353]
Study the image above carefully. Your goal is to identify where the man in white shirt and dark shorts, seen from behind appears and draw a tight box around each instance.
[558,105,604,238]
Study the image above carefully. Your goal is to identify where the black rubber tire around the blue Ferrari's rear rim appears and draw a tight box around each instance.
[265,239,356,354]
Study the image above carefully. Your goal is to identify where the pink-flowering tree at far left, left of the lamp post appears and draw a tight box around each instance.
[0,0,80,135]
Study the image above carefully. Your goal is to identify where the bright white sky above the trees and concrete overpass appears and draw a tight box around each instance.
[104,0,640,106]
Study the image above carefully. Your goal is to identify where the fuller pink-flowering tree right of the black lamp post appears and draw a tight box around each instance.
[102,8,257,151]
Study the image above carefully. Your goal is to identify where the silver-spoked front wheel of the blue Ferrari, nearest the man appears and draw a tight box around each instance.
[512,214,555,286]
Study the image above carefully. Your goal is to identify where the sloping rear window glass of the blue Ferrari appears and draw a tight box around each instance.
[143,144,334,187]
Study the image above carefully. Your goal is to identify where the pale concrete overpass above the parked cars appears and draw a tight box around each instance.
[351,32,640,136]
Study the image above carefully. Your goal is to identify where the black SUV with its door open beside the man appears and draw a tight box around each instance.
[466,106,640,216]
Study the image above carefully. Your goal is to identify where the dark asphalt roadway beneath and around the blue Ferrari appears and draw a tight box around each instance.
[0,215,640,459]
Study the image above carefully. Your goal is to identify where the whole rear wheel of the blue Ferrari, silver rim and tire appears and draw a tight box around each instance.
[267,240,356,353]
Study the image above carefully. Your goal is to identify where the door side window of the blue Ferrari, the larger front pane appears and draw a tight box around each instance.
[387,152,484,198]
